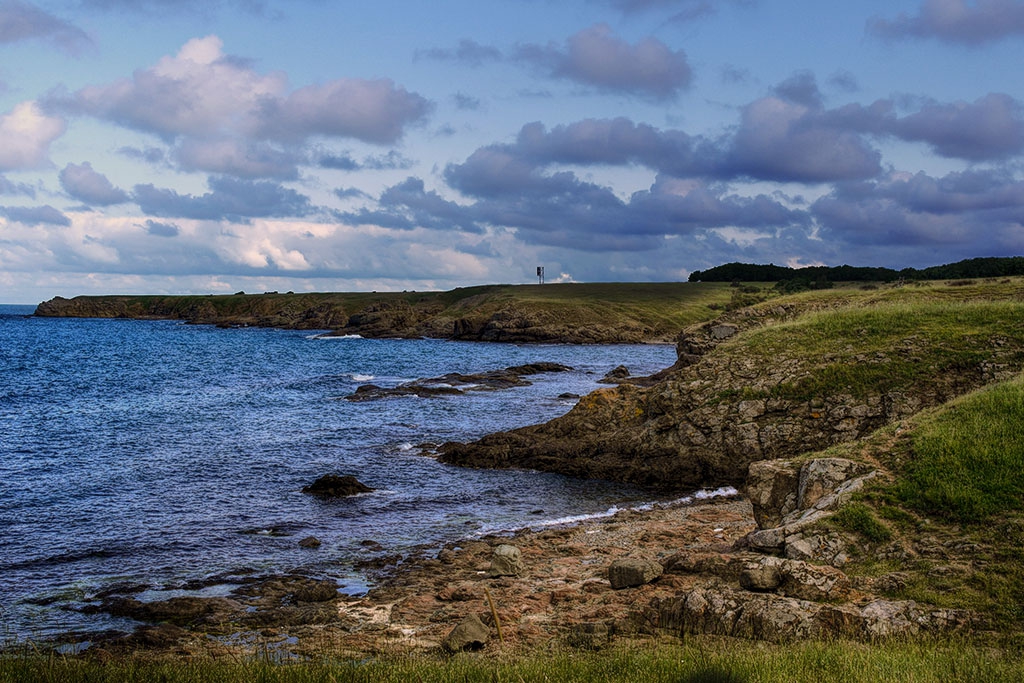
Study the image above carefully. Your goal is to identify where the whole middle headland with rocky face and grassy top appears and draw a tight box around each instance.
[439,282,1024,489]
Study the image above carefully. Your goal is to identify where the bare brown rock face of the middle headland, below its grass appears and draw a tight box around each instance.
[440,306,1024,490]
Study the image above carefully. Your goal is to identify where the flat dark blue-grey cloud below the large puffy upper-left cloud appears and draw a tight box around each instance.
[132,176,313,221]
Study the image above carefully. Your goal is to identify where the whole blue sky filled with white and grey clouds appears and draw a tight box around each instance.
[0,0,1024,303]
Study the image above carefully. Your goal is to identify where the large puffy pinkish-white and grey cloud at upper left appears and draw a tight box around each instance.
[55,36,430,158]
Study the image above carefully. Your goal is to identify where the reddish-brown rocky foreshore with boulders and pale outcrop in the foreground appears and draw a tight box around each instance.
[64,459,980,657]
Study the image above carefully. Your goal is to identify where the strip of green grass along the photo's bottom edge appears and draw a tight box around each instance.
[0,638,1024,683]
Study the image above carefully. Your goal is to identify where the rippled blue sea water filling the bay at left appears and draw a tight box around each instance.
[0,306,675,640]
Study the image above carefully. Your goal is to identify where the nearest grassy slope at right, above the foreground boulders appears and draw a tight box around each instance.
[806,377,1024,634]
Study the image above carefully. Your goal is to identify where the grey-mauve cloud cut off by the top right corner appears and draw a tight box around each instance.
[867,0,1024,45]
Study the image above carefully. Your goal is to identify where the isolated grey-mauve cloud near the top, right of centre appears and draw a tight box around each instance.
[514,24,693,100]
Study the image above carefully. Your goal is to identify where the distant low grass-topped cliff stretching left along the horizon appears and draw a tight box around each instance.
[35,283,735,344]
